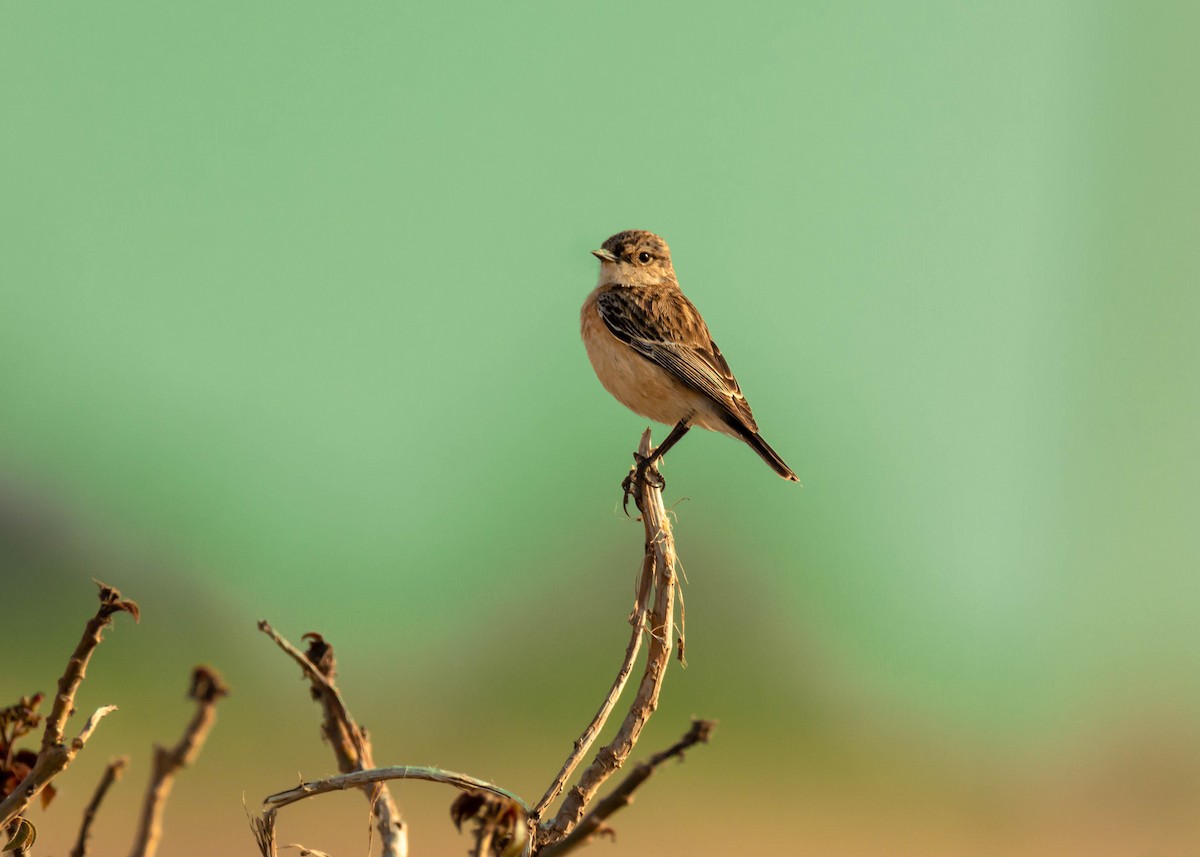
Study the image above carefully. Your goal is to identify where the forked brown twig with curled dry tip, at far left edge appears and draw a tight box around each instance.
[0,581,138,829]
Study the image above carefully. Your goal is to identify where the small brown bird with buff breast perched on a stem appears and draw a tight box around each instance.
[581,229,799,490]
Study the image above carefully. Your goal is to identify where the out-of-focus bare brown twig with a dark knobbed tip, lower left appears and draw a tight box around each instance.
[131,666,229,857]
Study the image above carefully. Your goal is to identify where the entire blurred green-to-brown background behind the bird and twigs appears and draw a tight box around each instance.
[0,0,1200,857]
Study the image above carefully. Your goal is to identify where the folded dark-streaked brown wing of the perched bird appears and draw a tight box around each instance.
[596,287,758,431]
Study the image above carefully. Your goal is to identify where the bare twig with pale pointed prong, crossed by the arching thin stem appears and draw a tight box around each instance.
[258,619,408,857]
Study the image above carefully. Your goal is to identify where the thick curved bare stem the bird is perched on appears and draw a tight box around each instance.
[539,429,677,846]
